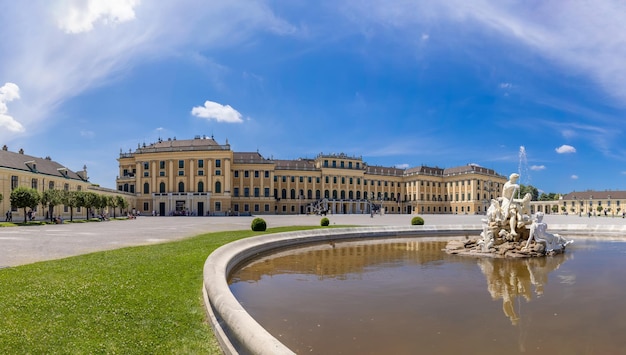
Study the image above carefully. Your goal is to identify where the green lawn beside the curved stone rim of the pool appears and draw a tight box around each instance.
[0,227,319,354]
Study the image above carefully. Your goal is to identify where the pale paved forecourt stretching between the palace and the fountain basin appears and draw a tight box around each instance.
[0,215,626,268]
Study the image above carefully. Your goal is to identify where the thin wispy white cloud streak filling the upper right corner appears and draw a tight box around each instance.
[344,0,626,104]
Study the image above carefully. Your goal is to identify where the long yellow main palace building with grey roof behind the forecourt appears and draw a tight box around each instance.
[116,136,507,216]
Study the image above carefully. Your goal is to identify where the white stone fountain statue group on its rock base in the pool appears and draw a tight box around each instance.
[446,173,572,258]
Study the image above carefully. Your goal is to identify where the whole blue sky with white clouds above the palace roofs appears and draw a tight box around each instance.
[0,0,626,193]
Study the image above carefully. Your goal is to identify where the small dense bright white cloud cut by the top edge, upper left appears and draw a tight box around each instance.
[57,0,139,33]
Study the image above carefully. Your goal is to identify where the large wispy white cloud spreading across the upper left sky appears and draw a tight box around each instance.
[0,0,300,141]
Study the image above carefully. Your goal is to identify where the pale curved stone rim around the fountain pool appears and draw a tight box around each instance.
[204,225,624,354]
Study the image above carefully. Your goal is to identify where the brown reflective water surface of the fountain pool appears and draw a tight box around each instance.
[230,238,626,354]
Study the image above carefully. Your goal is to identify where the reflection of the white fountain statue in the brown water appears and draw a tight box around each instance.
[478,254,570,325]
